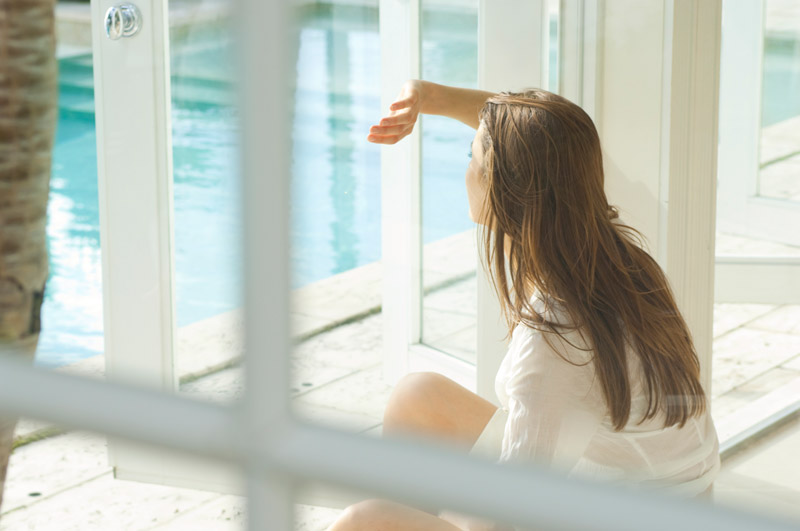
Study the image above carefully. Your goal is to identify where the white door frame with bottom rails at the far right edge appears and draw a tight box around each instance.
[716,0,800,304]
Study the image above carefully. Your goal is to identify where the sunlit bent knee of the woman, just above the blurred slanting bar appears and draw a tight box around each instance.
[383,372,447,432]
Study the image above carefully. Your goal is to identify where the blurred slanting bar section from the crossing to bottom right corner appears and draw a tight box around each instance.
[270,423,797,531]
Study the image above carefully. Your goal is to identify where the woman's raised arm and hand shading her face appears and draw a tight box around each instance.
[367,79,494,144]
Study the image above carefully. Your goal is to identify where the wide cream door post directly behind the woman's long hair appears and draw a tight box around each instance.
[584,0,721,391]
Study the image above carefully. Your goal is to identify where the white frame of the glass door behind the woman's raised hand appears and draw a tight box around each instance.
[379,0,548,402]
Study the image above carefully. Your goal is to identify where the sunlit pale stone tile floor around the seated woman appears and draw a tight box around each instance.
[0,276,800,531]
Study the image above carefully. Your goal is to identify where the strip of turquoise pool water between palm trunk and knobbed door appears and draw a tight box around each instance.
[36,48,103,367]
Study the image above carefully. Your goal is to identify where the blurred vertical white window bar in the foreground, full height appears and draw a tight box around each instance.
[237,0,298,530]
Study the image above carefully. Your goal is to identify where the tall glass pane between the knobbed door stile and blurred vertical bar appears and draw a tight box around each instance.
[169,1,242,395]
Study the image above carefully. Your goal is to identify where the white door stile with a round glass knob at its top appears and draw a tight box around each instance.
[92,0,177,477]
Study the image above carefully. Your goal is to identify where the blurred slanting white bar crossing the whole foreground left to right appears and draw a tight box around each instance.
[0,356,796,531]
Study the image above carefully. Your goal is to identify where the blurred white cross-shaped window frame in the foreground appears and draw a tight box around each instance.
[6,0,794,531]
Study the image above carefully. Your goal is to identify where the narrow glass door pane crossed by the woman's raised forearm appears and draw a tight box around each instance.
[422,0,478,363]
